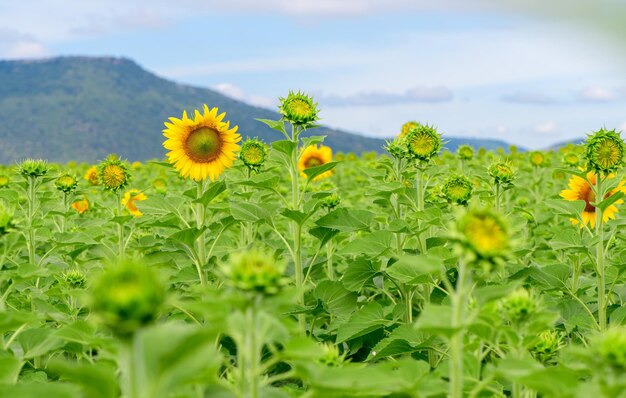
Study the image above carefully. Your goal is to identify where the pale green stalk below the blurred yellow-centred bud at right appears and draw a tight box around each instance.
[449,260,467,398]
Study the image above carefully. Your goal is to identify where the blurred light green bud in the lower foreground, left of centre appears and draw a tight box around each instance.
[223,249,285,295]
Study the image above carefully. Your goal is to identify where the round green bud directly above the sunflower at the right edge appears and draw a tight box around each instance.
[585,128,625,174]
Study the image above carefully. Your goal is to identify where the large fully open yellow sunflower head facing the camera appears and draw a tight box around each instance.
[163,105,241,181]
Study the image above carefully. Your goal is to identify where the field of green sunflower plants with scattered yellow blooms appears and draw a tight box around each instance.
[0,92,626,398]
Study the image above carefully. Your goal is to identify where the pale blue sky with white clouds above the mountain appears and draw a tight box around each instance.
[0,0,626,148]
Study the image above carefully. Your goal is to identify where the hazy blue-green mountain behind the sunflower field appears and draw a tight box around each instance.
[0,57,508,163]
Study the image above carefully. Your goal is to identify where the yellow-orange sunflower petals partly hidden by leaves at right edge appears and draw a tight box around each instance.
[561,171,626,228]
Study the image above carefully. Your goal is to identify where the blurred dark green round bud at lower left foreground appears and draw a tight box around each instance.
[92,262,165,337]
